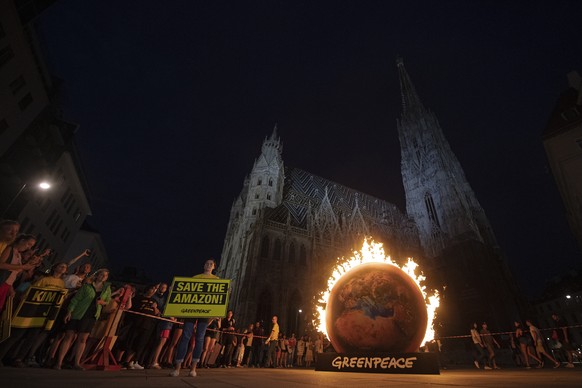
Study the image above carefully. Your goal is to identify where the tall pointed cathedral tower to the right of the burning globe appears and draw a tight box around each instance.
[397,58,518,332]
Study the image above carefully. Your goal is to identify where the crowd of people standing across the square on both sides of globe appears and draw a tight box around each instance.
[0,220,574,376]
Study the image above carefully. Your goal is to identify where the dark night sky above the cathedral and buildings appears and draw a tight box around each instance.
[39,0,582,295]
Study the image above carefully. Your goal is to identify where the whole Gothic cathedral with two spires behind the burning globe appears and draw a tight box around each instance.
[218,60,518,335]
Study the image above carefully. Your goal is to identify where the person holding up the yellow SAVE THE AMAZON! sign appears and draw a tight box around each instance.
[170,259,218,377]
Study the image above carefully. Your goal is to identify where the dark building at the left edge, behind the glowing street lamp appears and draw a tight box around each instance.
[0,0,106,265]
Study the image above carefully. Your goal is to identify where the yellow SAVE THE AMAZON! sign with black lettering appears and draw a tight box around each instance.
[163,277,230,318]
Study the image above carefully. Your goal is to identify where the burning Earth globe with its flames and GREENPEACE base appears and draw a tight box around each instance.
[315,240,439,373]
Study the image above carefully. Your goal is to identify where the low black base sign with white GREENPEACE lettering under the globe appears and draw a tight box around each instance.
[315,353,440,375]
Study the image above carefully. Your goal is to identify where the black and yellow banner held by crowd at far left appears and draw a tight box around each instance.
[12,286,67,330]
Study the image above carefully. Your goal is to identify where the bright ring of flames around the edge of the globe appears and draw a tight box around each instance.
[313,239,440,344]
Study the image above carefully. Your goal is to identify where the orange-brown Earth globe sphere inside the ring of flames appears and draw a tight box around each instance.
[326,263,428,353]
